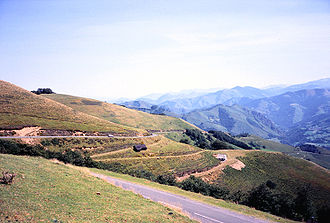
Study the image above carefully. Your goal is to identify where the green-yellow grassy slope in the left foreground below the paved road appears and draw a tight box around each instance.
[0,154,192,222]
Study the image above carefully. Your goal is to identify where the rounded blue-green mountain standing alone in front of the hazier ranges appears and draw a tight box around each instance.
[183,105,281,138]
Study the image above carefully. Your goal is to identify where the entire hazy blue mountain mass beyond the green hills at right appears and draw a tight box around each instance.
[122,78,330,148]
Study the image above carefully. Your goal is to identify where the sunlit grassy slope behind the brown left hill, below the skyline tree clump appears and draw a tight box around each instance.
[44,94,194,130]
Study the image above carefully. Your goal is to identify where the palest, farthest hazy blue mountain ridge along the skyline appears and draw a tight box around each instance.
[122,78,330,114]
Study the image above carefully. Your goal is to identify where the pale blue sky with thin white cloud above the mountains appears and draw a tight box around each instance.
[0,0,330,99]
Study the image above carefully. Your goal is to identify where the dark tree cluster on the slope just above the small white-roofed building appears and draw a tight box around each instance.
[180,129,252,150]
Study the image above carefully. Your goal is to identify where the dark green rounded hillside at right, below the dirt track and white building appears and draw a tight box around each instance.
[216,151,330,206]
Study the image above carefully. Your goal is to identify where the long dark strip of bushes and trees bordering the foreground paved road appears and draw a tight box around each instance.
[0,140,330,222]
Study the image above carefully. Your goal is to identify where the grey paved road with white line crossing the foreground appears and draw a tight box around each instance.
[91,172,270,223]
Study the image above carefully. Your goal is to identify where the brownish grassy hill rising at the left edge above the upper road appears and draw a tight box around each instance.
[0,81,140,133]
